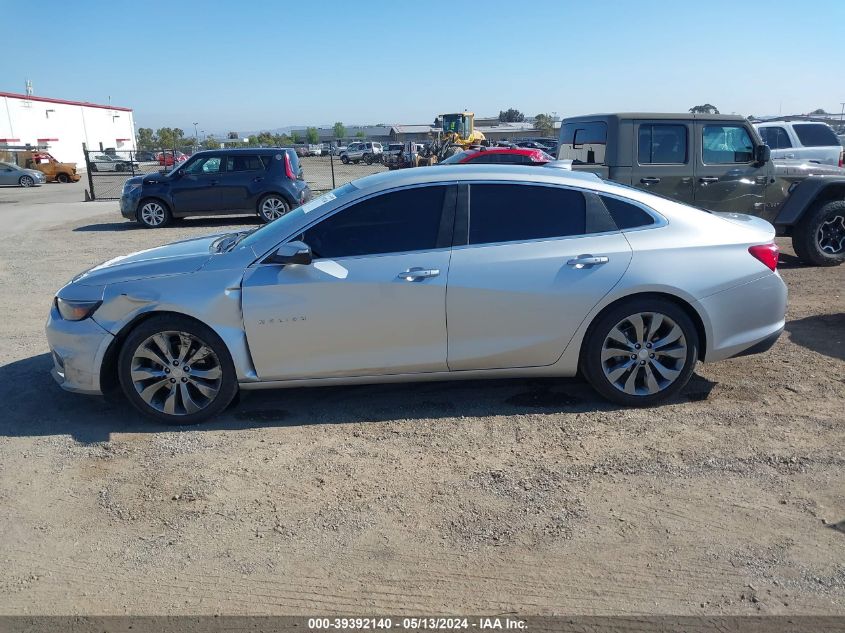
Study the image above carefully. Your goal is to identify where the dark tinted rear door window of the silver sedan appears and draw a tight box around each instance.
[469,185,586,244]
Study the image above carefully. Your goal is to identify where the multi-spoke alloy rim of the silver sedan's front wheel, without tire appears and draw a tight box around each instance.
[131,331,223,416]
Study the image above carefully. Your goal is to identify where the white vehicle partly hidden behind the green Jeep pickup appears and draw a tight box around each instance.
[754,119,845,167]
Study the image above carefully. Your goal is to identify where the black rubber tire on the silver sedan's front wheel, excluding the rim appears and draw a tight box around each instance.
[117,314,238,425]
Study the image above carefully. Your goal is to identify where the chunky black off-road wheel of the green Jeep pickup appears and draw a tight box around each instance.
[792,200,845,266]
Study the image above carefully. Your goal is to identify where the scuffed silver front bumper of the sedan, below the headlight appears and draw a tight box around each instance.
[46,306,114,395]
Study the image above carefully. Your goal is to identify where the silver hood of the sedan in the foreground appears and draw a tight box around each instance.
[73,233,225,286]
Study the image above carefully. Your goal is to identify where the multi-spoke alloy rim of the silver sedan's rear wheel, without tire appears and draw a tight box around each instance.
[601,312,687,396]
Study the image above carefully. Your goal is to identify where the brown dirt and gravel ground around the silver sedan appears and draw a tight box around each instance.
[0,192,845,615]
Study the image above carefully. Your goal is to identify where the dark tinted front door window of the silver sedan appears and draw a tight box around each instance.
[304,187,446,259]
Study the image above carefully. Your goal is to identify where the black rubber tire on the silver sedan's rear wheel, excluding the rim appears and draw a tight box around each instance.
[580,296,699,407]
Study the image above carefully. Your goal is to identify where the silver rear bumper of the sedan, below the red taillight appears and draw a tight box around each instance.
[698,273,787,363]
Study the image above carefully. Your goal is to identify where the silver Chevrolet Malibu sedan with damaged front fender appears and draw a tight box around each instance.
[47,165,787,424]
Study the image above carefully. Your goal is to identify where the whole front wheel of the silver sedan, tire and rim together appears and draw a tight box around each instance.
[118,315,238,424]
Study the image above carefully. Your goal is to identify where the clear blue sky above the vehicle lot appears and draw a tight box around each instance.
[0,0,845,134]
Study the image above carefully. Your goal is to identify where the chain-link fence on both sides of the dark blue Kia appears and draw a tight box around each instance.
[83,148,387,200]
